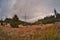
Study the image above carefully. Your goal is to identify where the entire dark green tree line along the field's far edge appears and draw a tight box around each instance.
[0,14,57,28]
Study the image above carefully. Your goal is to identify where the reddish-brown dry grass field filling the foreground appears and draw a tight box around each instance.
[0,23,60,40]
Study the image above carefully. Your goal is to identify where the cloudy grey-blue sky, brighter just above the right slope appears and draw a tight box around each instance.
[0,0,60,22]
